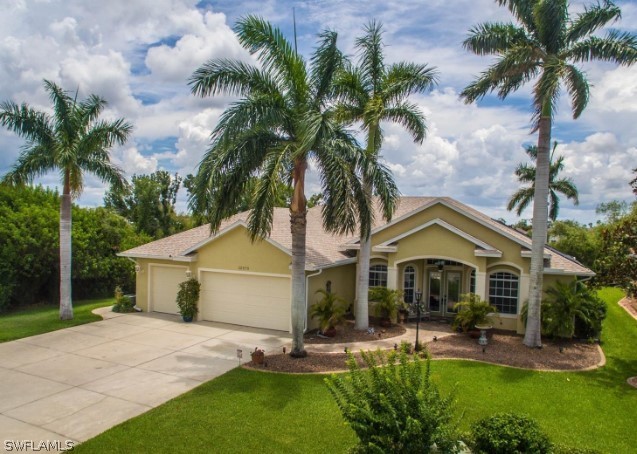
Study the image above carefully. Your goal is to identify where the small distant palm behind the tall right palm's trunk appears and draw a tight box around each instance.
[507,141,579,221]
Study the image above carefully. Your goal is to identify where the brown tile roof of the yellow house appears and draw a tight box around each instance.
[121,197,592,275]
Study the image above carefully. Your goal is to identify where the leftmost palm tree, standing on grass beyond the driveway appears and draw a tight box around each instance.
[0,80,132,320]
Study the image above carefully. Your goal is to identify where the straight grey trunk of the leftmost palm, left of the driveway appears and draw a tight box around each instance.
[60,171,73,320]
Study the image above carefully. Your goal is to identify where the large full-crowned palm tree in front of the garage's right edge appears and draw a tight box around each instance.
[190,16,391,357]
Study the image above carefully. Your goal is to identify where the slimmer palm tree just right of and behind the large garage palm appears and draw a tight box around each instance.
[337,21,437,330]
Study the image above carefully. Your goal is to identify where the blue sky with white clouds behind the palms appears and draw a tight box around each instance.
[0,0,637,223]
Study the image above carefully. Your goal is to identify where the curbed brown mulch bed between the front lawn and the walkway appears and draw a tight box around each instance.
[244,332,603,373]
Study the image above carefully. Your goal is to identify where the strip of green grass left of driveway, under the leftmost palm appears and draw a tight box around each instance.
[0,298,114,342]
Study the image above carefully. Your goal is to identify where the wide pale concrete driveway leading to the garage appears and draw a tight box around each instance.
[0,308,291,451]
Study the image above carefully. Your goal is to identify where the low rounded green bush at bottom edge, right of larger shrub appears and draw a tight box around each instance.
[471,413,552,454]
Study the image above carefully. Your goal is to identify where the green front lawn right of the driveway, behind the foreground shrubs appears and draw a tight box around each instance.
[76,289,637,454]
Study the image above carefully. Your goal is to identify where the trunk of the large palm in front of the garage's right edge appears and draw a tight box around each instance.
[290,159,307,358]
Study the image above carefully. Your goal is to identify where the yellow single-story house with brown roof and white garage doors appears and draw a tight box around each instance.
[119,197,594,333]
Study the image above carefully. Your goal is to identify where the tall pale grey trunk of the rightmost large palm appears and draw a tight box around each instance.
[524,114,551,347]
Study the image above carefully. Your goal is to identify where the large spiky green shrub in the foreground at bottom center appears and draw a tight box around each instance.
[326,350,458,453]
